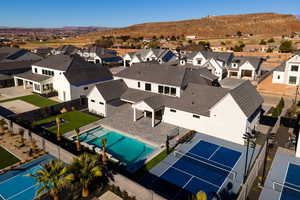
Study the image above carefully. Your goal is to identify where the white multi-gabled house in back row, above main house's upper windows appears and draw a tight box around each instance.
[123,49,177,67]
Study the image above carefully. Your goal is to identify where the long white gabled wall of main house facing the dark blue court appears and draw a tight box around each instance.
[163,95,247,144]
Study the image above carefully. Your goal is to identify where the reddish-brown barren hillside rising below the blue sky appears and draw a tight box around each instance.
[72,13,300,41]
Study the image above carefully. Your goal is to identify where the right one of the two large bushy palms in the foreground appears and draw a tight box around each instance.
[69,153,102,197]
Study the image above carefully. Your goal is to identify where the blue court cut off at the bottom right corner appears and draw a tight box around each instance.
[273,163,300,200]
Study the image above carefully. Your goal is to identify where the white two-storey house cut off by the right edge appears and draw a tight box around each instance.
[272,53,300,85]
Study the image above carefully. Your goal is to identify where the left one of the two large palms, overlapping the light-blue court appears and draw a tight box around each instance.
[28,160,74,200]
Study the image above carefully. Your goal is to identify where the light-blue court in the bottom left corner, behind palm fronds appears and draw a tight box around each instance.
[0,155,53,200]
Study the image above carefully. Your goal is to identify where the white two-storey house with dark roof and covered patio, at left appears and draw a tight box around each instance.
[14,54,112,101]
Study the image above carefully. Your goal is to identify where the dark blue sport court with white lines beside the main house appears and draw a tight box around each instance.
[154,140,241,199]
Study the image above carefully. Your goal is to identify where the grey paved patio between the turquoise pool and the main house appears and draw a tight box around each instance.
[99,104,188,145]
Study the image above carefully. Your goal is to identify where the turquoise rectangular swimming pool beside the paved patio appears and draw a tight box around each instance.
[77,127,155,165]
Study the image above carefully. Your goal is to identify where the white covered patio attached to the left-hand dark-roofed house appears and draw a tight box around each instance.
[14,72,53,94]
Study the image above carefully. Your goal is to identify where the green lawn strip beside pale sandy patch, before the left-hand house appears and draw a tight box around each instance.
[0,94,58,108]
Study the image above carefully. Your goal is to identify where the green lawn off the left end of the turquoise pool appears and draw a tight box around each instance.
[36,111,99,134]
